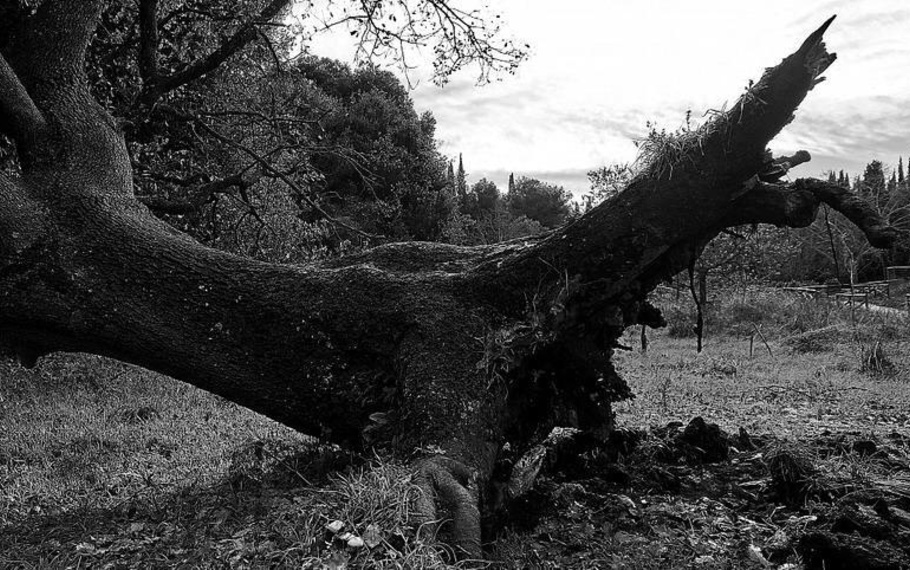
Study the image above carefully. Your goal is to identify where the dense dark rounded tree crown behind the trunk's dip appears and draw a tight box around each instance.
[292,58,454,240]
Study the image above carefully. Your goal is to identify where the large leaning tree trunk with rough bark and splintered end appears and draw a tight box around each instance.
[0,4,897,554]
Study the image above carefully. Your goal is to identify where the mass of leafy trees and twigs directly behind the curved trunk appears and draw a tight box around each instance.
[79,2,488,261]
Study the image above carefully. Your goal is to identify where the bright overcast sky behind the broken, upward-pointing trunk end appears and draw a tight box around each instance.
[306,0,910,194]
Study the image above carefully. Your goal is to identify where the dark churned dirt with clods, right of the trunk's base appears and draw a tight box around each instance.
[498,418,910,570]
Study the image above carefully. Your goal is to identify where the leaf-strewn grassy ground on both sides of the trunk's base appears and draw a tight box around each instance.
[0,290,910,569]
